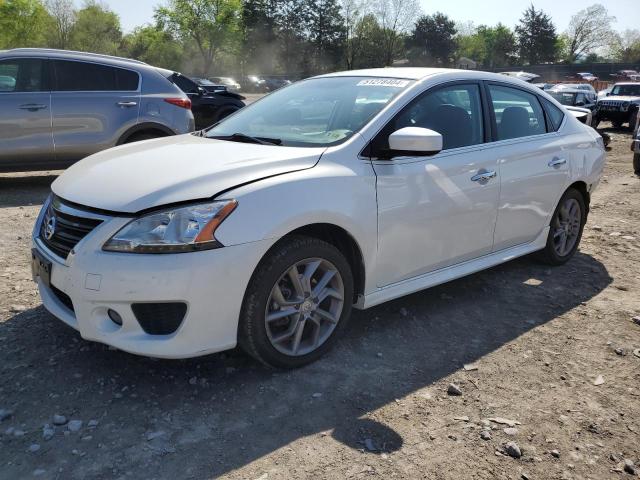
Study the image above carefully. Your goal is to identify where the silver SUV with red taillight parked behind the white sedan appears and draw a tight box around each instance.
[0,48,194,171]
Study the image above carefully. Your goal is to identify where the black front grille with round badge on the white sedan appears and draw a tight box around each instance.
[40,203,102,258]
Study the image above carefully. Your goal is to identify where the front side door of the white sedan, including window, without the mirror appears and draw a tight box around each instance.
[366,82,500,287]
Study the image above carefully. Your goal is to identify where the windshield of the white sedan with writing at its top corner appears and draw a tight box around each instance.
[205,77,413,147]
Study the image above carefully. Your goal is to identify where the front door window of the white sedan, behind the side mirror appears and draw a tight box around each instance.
[372,84,484,156]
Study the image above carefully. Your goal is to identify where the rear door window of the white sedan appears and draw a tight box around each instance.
[489,85,547,140]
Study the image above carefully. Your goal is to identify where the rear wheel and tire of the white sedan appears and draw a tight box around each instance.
[539,188,587,265]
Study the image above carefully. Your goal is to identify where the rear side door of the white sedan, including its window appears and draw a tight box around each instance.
[487,83,571,251]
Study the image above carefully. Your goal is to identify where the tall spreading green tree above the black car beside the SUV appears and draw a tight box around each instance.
[155,0,242,76]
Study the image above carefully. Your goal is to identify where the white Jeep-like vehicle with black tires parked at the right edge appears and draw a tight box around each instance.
[595,82,640,130]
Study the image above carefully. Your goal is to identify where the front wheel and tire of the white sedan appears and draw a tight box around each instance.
[238,236,353,368]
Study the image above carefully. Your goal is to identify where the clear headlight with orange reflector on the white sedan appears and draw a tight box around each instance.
[102,200,238,253]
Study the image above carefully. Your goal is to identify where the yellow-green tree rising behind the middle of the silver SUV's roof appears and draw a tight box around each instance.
[71,0,122,55]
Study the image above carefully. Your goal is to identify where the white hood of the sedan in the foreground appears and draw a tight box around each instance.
[51,135,325,213]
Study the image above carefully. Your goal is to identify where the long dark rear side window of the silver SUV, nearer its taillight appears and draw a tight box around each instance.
[54,60,138,92]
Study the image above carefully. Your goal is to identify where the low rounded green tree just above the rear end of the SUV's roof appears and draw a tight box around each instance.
[122,26,184,70]
